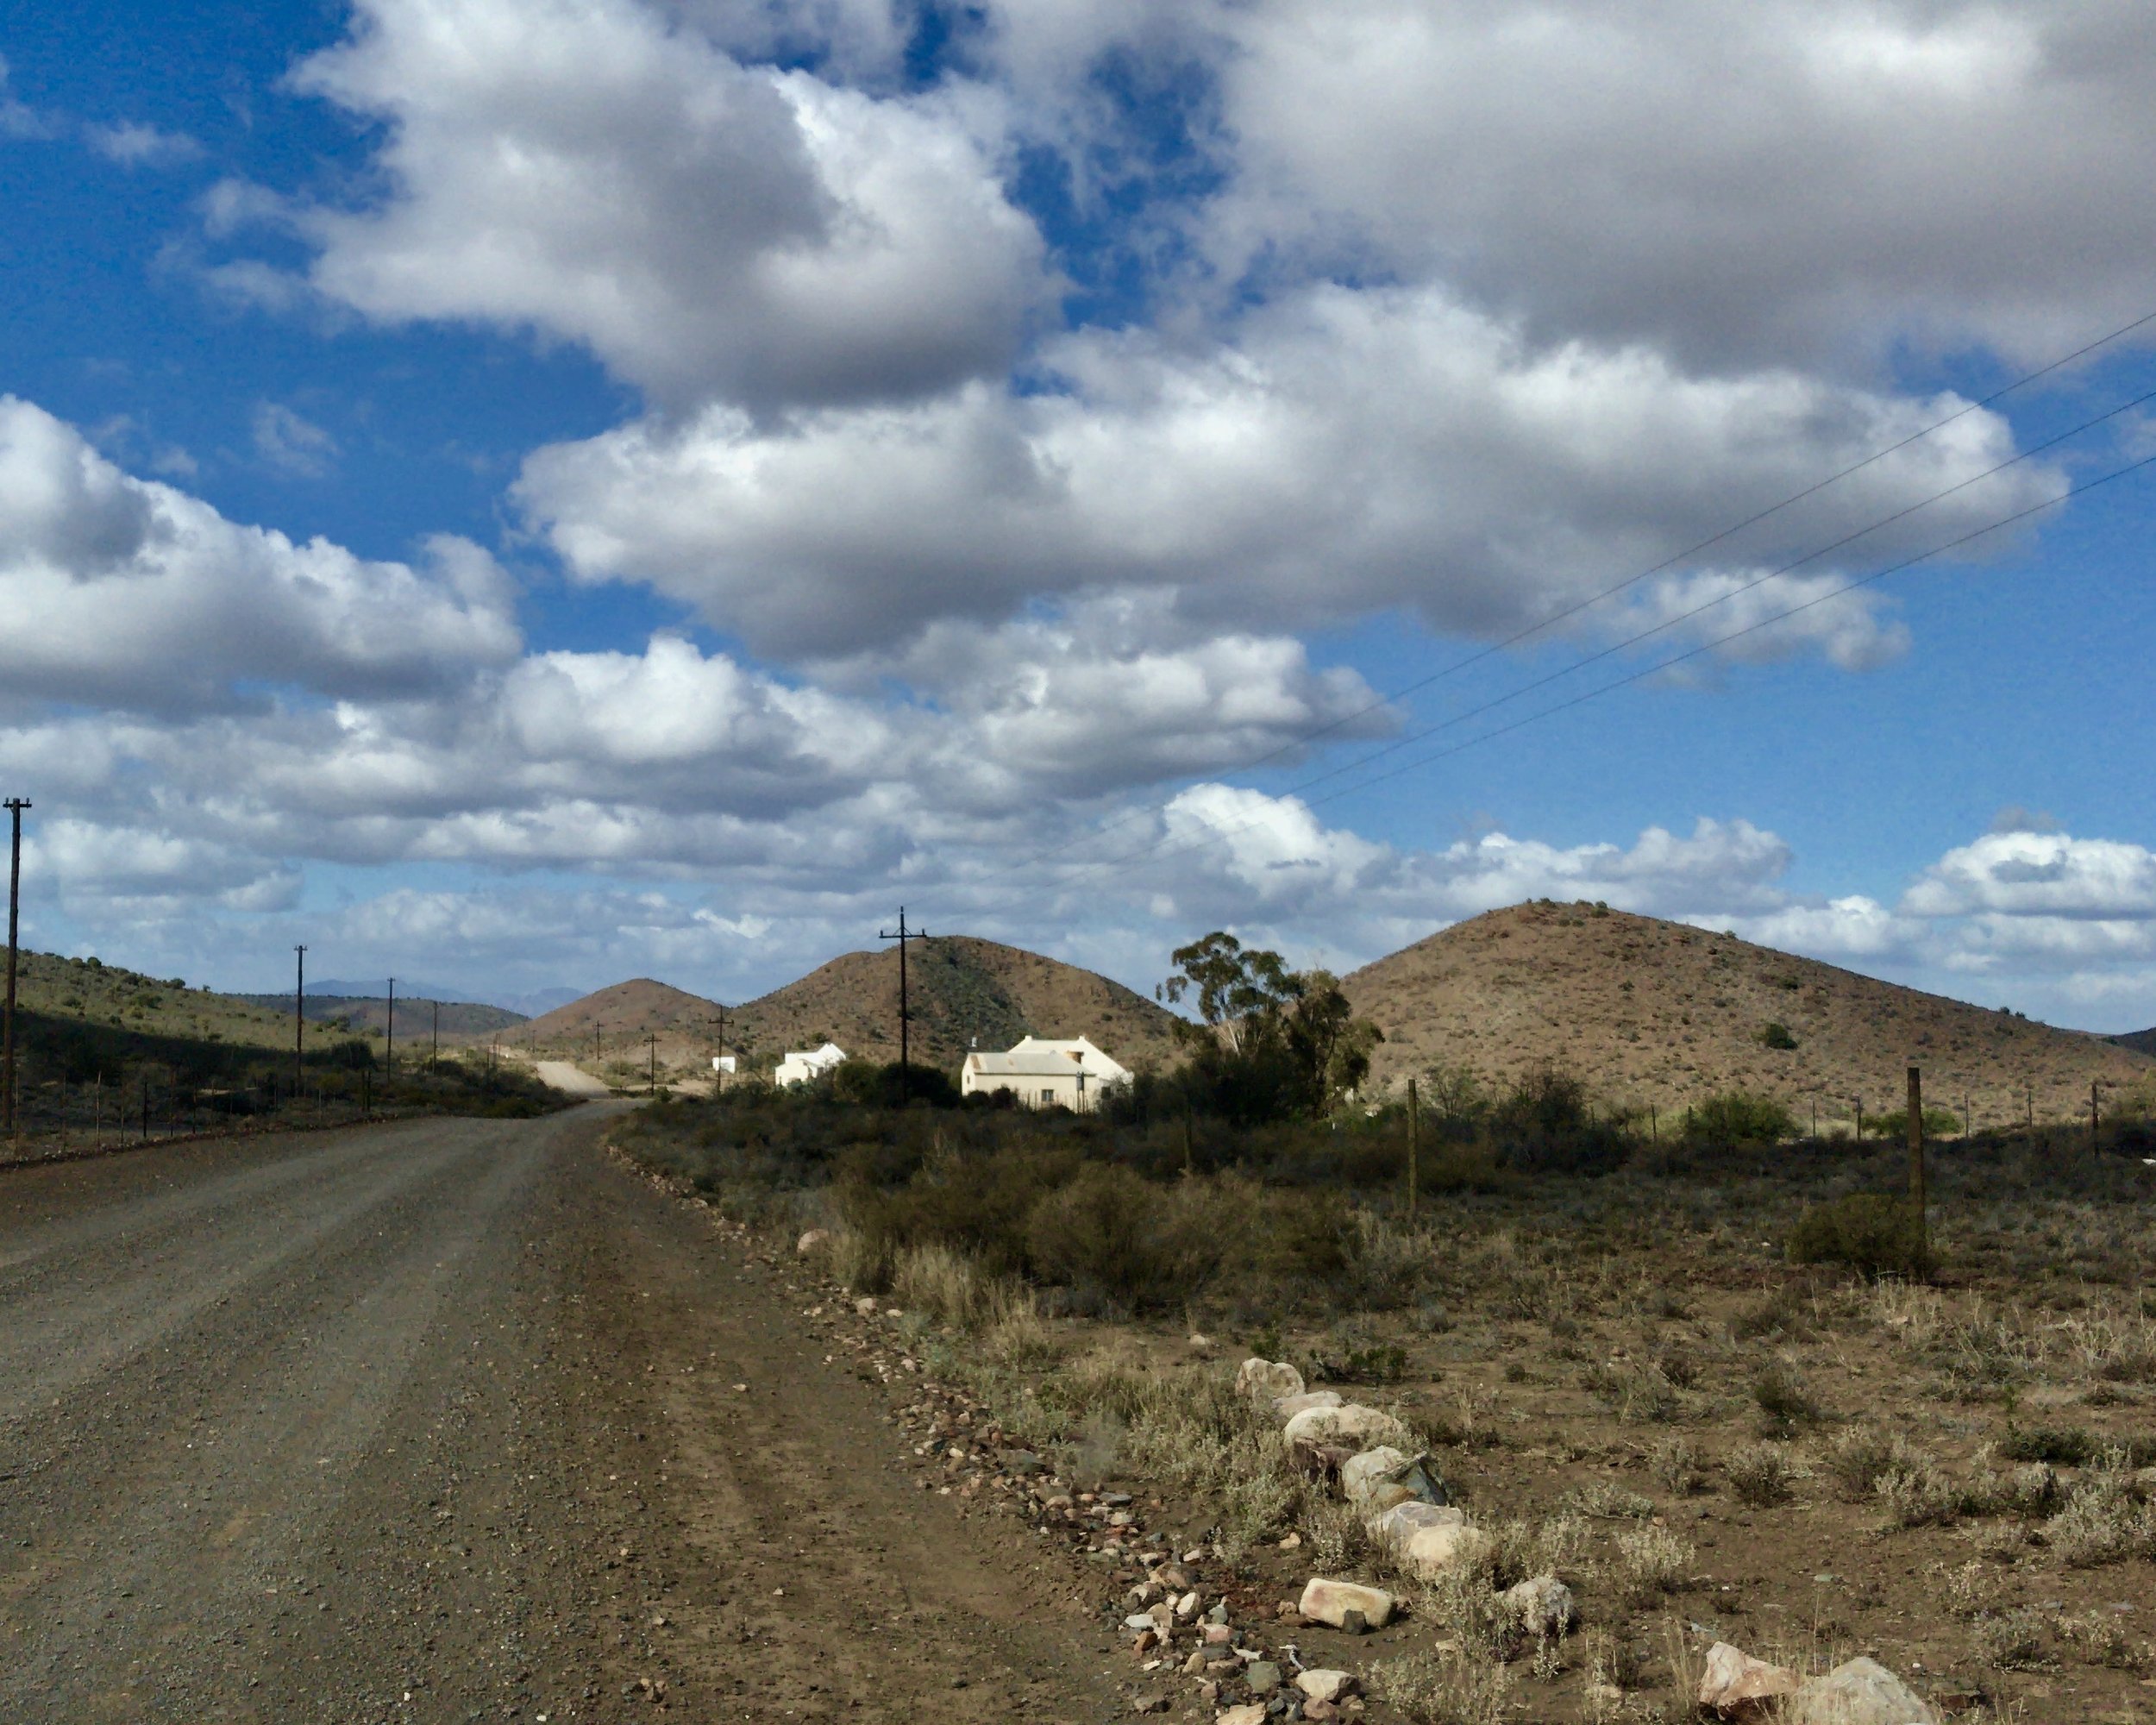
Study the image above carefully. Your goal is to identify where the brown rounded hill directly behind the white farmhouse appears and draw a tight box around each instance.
[727,934,1175,1072]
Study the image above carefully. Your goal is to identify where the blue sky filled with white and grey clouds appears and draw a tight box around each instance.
[0,0,2156,1029]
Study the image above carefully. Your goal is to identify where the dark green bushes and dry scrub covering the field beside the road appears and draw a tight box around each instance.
[617,932,2156,1721]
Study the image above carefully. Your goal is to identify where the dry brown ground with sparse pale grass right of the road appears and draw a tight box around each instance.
[617,1107,2156,1725]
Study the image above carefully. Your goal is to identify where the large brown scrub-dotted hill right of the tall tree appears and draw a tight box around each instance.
[1344,904,2156,1130]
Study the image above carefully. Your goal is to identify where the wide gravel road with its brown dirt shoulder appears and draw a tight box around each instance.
[0,1104,1117,1725]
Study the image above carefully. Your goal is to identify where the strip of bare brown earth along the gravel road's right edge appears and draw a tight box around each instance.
[567,1171,1128,1725]
